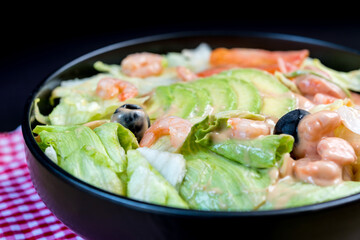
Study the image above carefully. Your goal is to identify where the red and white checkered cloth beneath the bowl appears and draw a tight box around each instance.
[0,127,82,240]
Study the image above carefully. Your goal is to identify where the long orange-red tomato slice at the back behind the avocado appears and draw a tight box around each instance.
[210,48,309,73]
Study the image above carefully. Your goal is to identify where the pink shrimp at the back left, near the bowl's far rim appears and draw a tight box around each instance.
[121,52,164,78]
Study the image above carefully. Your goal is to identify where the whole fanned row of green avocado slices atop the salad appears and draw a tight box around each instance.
[145,68,296,120]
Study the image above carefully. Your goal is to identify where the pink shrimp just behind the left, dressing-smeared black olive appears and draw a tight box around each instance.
[96,77,138,101]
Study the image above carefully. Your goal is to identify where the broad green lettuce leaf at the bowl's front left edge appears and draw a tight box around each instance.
[33,124,125,195]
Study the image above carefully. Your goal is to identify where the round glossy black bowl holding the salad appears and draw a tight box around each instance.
[22,32,360,239]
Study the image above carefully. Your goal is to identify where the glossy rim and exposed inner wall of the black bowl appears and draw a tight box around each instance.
[22,32,360,215]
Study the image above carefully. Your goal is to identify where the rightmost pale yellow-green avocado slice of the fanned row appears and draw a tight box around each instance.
[218,68,296,118]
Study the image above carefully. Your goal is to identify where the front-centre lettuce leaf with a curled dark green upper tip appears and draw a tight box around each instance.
[180,114,272,211]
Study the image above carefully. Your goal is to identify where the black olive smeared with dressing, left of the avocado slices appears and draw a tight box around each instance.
[110,104,150,141]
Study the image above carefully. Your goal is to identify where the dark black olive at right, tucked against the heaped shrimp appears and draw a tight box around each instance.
[274,109,310,143]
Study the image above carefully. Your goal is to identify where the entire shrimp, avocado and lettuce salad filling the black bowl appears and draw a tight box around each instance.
[33,43,360,211]
